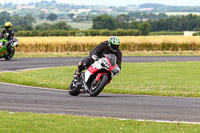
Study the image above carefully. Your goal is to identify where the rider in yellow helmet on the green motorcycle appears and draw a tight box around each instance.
[1,22,14,53]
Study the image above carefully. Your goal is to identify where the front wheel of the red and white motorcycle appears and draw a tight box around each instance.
[90,74,108,97]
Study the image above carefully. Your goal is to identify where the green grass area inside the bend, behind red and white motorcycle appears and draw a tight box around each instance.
[0,62,200,97]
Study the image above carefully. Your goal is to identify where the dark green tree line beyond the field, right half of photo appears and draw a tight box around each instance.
[93,14,200,32]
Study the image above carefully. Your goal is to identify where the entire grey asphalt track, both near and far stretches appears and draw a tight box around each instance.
[0,56,200,122]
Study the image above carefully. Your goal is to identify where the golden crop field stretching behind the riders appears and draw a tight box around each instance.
[17,36,200,52]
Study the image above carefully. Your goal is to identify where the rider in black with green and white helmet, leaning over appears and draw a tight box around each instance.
[73,36,122,78]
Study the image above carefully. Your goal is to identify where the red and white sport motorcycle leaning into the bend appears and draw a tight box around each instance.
[69,54,120,97]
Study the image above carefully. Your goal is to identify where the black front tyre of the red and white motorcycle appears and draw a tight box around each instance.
[90,74,108,97]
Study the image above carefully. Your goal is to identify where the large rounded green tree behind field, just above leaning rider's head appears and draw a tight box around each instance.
[92,15,116,30]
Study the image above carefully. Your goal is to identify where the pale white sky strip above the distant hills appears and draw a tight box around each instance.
[0,0,200,6]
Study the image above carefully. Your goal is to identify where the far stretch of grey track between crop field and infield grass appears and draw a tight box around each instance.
[0,56,200,71]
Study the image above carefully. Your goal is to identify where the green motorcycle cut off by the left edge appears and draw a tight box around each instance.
[0,38,18,60]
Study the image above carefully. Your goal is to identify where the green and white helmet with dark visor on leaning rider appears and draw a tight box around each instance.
[108,36,120,52]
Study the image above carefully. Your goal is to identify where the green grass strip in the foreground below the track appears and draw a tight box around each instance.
[0,112,200,133]
